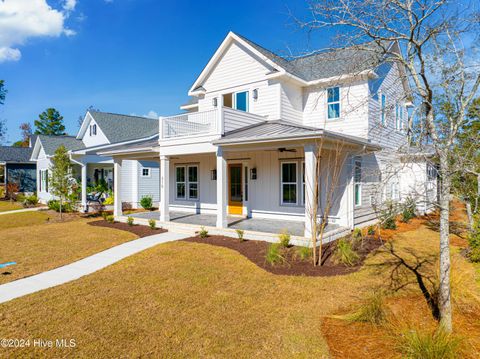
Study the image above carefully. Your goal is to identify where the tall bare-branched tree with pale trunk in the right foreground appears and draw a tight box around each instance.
[300,0,480,331]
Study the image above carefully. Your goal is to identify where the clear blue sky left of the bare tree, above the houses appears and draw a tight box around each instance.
[0,0,328,142]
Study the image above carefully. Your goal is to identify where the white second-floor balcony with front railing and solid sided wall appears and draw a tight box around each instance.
[160,107,266,139]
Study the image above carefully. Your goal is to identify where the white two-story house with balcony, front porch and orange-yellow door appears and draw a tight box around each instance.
[96,32,436,237]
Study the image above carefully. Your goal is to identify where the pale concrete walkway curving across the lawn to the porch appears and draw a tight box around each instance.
[0,232,188,303]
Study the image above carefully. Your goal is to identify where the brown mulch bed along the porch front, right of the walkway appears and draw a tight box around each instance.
[184,236,382,277]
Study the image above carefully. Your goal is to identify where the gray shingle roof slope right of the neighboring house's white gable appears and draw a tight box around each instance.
[89,111,159,143]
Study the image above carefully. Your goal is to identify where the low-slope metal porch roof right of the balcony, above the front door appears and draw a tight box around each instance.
[213,120,380,150]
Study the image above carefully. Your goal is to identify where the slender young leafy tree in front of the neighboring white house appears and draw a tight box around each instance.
[49,145,74,218]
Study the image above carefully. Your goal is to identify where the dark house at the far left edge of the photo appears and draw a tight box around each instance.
[0,140,36,198]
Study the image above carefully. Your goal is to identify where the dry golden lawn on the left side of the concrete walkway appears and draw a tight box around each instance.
[0,217,137,284]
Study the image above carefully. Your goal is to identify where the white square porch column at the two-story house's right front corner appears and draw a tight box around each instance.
[304,144,318,238]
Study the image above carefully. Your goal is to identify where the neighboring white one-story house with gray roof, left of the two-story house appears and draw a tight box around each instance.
[32,111,159,208]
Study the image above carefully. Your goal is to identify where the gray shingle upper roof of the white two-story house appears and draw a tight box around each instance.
[236,34,383,81]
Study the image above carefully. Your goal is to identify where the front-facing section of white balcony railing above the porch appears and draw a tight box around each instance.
[160,110,218,138]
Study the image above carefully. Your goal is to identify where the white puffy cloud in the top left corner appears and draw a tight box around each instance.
[0,0,77,62]
